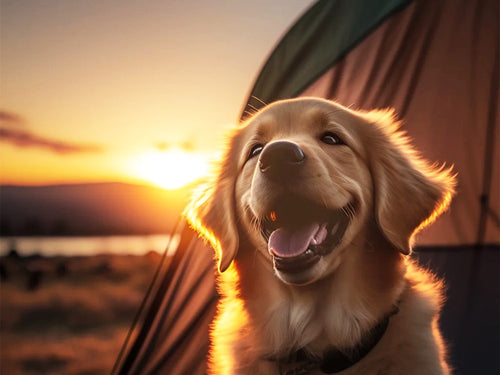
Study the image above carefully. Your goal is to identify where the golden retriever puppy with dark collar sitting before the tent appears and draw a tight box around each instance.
[186,98,455,375]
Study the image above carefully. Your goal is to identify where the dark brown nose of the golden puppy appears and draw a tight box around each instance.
[259,141,306,179]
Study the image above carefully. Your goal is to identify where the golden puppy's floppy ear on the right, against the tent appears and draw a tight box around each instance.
[365,110,455,254]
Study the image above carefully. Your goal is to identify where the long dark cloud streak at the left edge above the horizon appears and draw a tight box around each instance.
[0,128,104,154]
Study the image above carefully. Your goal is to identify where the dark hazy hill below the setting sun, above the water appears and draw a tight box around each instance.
[0,183,195,236]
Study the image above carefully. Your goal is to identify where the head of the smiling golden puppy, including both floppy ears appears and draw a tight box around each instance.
[188,98,454,284]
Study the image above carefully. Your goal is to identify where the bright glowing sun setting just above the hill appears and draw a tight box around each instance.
[132,148,210,190]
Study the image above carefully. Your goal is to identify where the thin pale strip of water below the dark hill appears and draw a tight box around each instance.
[0,235,179,256]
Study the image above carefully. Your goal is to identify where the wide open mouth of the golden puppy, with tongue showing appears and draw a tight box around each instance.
[261,197,353,273]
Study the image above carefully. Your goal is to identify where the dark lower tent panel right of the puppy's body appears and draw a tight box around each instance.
[414,245,500,375]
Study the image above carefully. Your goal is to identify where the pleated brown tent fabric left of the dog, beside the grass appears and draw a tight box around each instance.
[112,222,218,375]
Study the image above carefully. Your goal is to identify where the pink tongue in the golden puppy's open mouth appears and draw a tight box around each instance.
[267,223,327,258]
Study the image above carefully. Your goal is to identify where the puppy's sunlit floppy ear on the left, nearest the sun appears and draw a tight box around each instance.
[184,137,239,272]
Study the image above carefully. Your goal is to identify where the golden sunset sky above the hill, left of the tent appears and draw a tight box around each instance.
[0,0,313,188]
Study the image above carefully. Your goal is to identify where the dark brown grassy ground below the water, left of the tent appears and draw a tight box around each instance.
[0,252,160,375]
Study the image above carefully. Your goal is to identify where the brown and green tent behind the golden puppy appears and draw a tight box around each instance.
[113,0,500,374]
